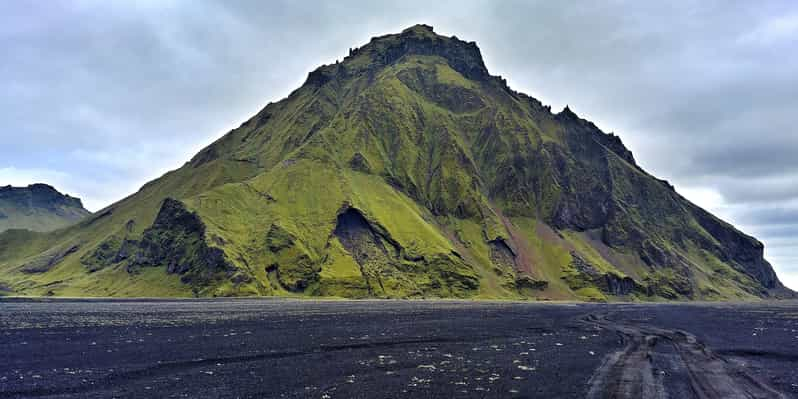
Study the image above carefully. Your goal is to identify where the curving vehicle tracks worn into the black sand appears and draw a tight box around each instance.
[584,314,787,399]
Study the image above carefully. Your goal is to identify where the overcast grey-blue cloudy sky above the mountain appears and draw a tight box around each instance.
[0,0,798,289]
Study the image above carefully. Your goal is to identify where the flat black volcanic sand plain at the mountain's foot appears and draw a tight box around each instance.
[0,299,798,398]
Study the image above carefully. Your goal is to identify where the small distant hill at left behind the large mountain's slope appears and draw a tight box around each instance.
[0,183,91,232]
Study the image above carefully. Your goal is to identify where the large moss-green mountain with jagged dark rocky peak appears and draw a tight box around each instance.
[0,25,793,300]
